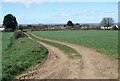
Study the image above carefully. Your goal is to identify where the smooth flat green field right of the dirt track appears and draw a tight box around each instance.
[32,30,118,58]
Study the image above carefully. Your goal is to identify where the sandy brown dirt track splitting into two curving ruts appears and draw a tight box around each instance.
[16,32,118,79]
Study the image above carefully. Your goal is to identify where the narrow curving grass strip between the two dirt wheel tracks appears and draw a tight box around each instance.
[29,34,81,58]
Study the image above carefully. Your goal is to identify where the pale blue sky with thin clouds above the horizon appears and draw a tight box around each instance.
[0,0,118,24]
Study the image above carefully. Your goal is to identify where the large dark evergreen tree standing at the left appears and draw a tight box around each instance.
[3,14,18,31]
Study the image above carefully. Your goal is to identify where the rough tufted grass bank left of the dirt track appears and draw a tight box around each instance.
[2,36,47,81]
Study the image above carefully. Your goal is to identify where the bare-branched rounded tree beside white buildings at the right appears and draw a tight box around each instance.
[101,17,114,29]
